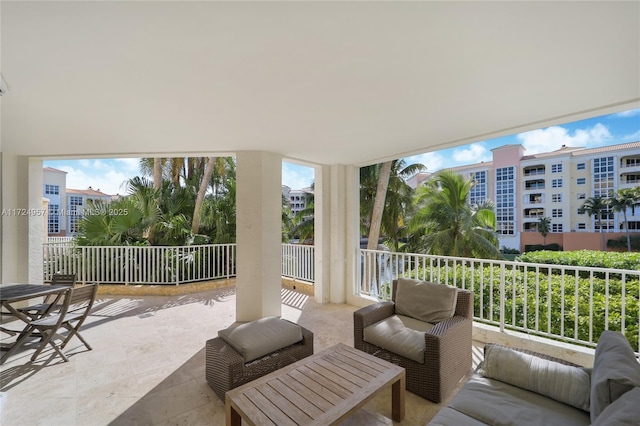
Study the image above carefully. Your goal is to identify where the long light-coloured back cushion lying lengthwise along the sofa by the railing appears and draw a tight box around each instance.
[482,345,591,412]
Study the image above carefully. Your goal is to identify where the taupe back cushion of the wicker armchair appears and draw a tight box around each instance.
[395,278,458,324]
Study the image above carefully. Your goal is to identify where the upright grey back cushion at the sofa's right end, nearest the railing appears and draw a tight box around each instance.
[591,330,640,423]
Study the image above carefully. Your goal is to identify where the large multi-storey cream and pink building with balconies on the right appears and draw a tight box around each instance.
[432,142,640,250]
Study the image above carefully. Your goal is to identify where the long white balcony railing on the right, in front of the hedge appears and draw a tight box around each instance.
[356,250,640,352]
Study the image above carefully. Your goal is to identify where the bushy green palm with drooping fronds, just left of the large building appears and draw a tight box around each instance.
[409,170,500,259]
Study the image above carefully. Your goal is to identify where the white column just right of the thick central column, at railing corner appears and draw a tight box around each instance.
[314,165,360,303]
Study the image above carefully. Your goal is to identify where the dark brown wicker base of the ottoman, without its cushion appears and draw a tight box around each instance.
[205,318,313,401]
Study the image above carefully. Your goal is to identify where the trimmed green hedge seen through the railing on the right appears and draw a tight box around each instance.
[407,265,640,350]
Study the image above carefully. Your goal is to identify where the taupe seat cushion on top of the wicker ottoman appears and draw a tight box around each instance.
[218,317,302,362]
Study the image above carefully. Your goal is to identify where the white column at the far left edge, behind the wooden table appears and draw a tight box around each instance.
[0,153,44,283]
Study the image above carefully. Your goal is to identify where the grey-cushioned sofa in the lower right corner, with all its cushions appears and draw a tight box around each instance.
[429,331,640,426]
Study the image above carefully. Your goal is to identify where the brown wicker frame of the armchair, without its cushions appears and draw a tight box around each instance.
[353,281,473,403]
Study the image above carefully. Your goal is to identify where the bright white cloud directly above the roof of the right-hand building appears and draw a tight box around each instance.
[517,123,613,154]
